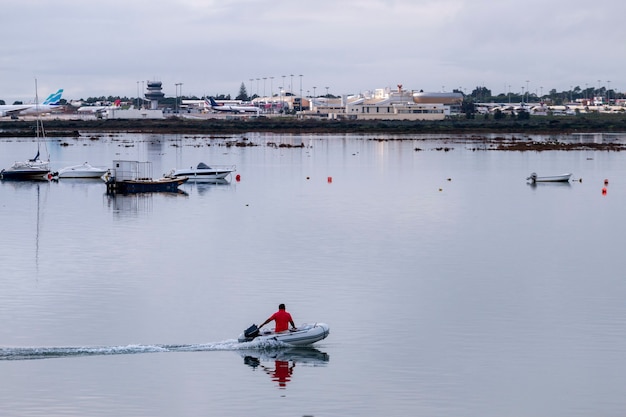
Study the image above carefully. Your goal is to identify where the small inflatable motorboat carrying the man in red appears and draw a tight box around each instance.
[237,323,330,346]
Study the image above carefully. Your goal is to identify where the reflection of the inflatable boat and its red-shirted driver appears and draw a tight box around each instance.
[238,347,329,389]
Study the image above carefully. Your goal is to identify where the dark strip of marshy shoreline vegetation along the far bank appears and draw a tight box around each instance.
[0,114,626,151]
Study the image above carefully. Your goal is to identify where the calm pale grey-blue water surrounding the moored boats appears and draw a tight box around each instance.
[0,134,626,417]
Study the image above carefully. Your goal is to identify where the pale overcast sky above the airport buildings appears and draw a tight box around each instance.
[0,0,626,104]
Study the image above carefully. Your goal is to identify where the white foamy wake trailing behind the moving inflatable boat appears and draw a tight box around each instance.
[0,339,316,361]
